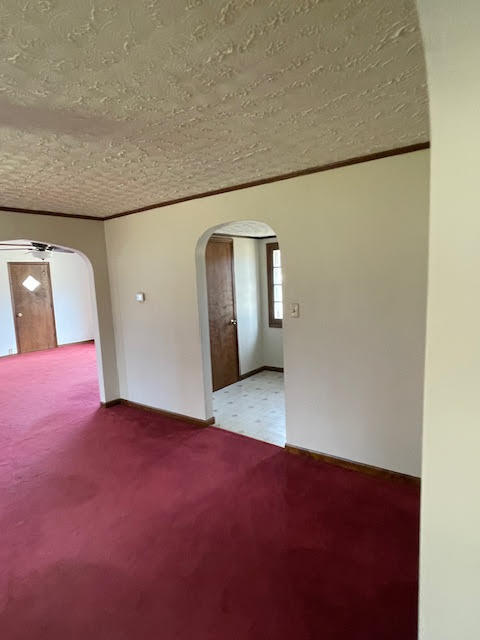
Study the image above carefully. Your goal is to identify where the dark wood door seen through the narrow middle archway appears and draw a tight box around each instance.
[205,236,239,391]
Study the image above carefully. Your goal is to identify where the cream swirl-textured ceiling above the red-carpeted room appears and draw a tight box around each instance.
[0,0,429,216]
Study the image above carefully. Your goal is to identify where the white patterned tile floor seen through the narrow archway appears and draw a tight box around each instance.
[213,371,285,447]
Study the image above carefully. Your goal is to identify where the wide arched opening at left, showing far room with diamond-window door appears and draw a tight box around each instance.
[0,239,103,406]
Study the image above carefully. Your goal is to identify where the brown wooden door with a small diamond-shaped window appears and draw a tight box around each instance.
[8,262,57,353]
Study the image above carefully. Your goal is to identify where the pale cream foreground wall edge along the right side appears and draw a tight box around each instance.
[418,0,480,640]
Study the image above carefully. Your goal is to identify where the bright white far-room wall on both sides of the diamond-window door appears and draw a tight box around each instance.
[0,250,94,356]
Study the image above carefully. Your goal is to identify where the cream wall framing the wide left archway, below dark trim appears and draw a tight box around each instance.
[0,210,118,401]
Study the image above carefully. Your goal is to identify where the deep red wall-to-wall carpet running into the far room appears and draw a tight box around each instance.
[0,345,419,640]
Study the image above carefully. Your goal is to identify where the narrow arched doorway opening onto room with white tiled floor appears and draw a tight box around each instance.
[197,220,286,447]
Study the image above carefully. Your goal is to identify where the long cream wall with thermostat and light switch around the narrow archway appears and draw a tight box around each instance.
[105,151,429,475]
